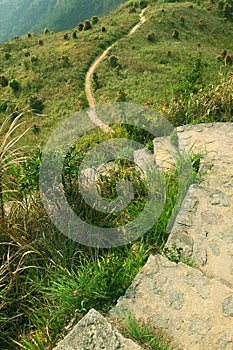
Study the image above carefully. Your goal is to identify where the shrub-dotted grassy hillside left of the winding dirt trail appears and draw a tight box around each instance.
[0,5,139,147]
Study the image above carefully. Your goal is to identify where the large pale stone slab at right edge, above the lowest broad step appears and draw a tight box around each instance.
[166,123,233,287]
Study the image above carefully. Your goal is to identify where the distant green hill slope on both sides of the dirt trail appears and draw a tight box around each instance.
[0,1,233,150]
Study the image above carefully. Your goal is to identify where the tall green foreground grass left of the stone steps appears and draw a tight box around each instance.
[0,119,195,349]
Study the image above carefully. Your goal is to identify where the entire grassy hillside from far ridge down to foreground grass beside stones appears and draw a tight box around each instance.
[0,0,233,350]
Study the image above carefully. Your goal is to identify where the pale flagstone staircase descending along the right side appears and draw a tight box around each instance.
[53,123,233,350]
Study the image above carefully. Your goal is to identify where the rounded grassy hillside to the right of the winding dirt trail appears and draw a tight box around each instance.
[95,2,233,124]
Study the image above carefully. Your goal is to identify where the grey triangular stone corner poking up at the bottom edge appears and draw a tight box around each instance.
[54,309,142,350]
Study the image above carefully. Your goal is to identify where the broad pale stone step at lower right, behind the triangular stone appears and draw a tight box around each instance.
[109,255,233,350]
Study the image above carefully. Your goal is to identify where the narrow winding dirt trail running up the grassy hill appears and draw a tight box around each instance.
[85,8,147,131]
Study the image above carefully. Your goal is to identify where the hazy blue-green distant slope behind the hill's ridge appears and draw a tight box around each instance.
[0,0,125,42]
